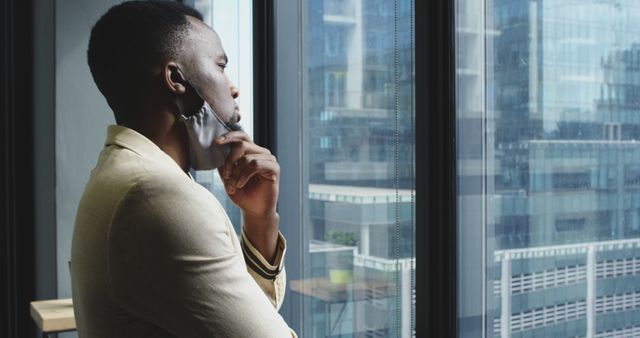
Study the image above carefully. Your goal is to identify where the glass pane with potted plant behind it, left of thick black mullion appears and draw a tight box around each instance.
[289,0,415,337]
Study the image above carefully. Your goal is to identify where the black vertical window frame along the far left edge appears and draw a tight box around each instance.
[0,0,36,337]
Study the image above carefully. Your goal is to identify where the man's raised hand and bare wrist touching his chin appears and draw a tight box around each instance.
[216,131,280,262]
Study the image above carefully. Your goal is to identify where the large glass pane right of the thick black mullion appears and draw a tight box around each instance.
[456,0,640,338]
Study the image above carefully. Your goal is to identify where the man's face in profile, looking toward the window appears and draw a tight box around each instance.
[181,17,240,125]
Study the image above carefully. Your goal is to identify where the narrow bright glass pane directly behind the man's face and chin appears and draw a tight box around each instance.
[192,0,253,233]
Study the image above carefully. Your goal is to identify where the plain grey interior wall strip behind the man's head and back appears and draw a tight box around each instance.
[55,0,121,338]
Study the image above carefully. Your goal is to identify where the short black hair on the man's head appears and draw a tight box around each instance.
[87,1,202,123]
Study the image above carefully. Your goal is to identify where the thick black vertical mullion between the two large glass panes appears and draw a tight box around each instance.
[415,1,457,337]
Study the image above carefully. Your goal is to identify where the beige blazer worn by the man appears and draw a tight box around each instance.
[71,125,296,338]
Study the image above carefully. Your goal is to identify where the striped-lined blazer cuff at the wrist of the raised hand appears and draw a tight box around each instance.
[240,228,287,310]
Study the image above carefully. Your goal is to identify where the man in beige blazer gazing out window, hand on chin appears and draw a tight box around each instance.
[71,1,296,338]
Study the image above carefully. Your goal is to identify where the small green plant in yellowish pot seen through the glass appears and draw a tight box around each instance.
[325,230,358,284]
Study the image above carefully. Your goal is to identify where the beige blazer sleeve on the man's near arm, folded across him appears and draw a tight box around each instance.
[108,177,296,338]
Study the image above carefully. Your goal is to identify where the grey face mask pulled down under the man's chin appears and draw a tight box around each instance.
[180,93,236,170]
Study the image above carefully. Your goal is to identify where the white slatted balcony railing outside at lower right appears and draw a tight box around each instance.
[493,238,640,338]
